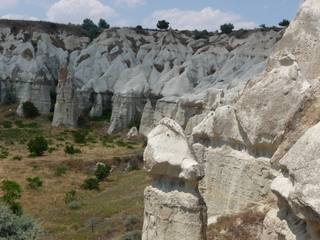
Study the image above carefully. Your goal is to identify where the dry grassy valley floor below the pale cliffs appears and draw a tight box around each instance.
[0,105,151,240]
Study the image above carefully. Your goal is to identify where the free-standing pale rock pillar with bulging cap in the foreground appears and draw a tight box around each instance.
[142,118,207,240]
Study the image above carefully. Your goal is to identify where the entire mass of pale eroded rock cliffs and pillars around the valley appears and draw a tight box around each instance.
[0,0,320,237]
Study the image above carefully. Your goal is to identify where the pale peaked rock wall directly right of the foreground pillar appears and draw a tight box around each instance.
[192,105,276,217]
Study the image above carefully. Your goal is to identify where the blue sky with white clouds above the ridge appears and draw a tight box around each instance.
[0,0,303,31]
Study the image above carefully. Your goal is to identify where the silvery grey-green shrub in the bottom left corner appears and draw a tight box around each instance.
[0,205,45,240]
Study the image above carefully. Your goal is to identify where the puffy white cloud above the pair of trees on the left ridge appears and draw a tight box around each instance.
[46,0,116,23]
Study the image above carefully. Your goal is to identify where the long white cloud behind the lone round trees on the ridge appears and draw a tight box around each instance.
[143,7,257,31]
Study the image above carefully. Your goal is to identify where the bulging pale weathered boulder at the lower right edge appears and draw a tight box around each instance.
[271,124,320,240]
